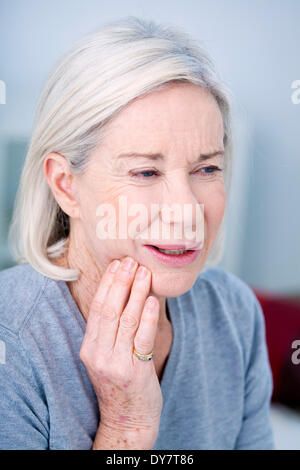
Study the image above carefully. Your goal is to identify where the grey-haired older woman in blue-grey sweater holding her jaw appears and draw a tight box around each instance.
[0,17,274,449]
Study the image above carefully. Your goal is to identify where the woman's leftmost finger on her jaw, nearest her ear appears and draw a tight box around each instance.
[86,259,121,337]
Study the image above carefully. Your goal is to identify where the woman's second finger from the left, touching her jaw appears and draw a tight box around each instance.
[99,256,138,351]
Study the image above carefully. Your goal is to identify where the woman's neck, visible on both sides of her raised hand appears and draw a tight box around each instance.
[55,230,169,331]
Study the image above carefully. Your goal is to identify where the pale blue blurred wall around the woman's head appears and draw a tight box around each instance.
[0,0,300,292]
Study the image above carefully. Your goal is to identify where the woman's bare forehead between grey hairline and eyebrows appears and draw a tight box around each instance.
[102,83,224,151]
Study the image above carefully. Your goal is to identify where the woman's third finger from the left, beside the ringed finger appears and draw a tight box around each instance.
[114,266,151,354]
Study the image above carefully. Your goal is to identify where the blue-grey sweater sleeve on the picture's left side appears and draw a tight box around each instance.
[0,327,48,450]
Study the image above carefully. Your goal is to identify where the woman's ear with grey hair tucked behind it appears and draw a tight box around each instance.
[43,152,79,218]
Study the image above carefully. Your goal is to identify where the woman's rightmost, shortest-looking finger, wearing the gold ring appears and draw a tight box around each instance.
[133,295,159,362]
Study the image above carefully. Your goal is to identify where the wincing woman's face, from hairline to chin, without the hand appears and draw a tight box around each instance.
[72,84,226,297]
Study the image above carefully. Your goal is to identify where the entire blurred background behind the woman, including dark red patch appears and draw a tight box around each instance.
[0,0,300,449]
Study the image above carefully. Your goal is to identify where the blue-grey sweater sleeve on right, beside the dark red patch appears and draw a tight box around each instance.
[235,293,275,450]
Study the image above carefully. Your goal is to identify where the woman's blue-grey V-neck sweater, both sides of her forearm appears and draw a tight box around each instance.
[0,264,275,450]
